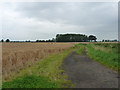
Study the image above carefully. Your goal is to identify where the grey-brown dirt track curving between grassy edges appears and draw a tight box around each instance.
[62,51,118,88]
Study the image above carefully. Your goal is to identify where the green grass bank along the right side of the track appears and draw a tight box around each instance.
[87,44,120,70]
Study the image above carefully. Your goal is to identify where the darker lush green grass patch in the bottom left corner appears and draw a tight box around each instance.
[3,75,59,88]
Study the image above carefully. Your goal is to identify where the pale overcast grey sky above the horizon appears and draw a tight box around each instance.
[0,2,118,40]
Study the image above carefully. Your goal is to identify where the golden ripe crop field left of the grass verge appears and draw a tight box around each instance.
[2,43,75,79]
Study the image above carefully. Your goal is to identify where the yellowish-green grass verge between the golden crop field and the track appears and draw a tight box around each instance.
[3,48,75,88]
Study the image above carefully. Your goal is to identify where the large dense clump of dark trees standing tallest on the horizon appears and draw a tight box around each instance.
[56,34,97,42]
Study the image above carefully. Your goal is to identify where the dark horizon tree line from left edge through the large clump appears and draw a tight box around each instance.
[1,34,97,42]
